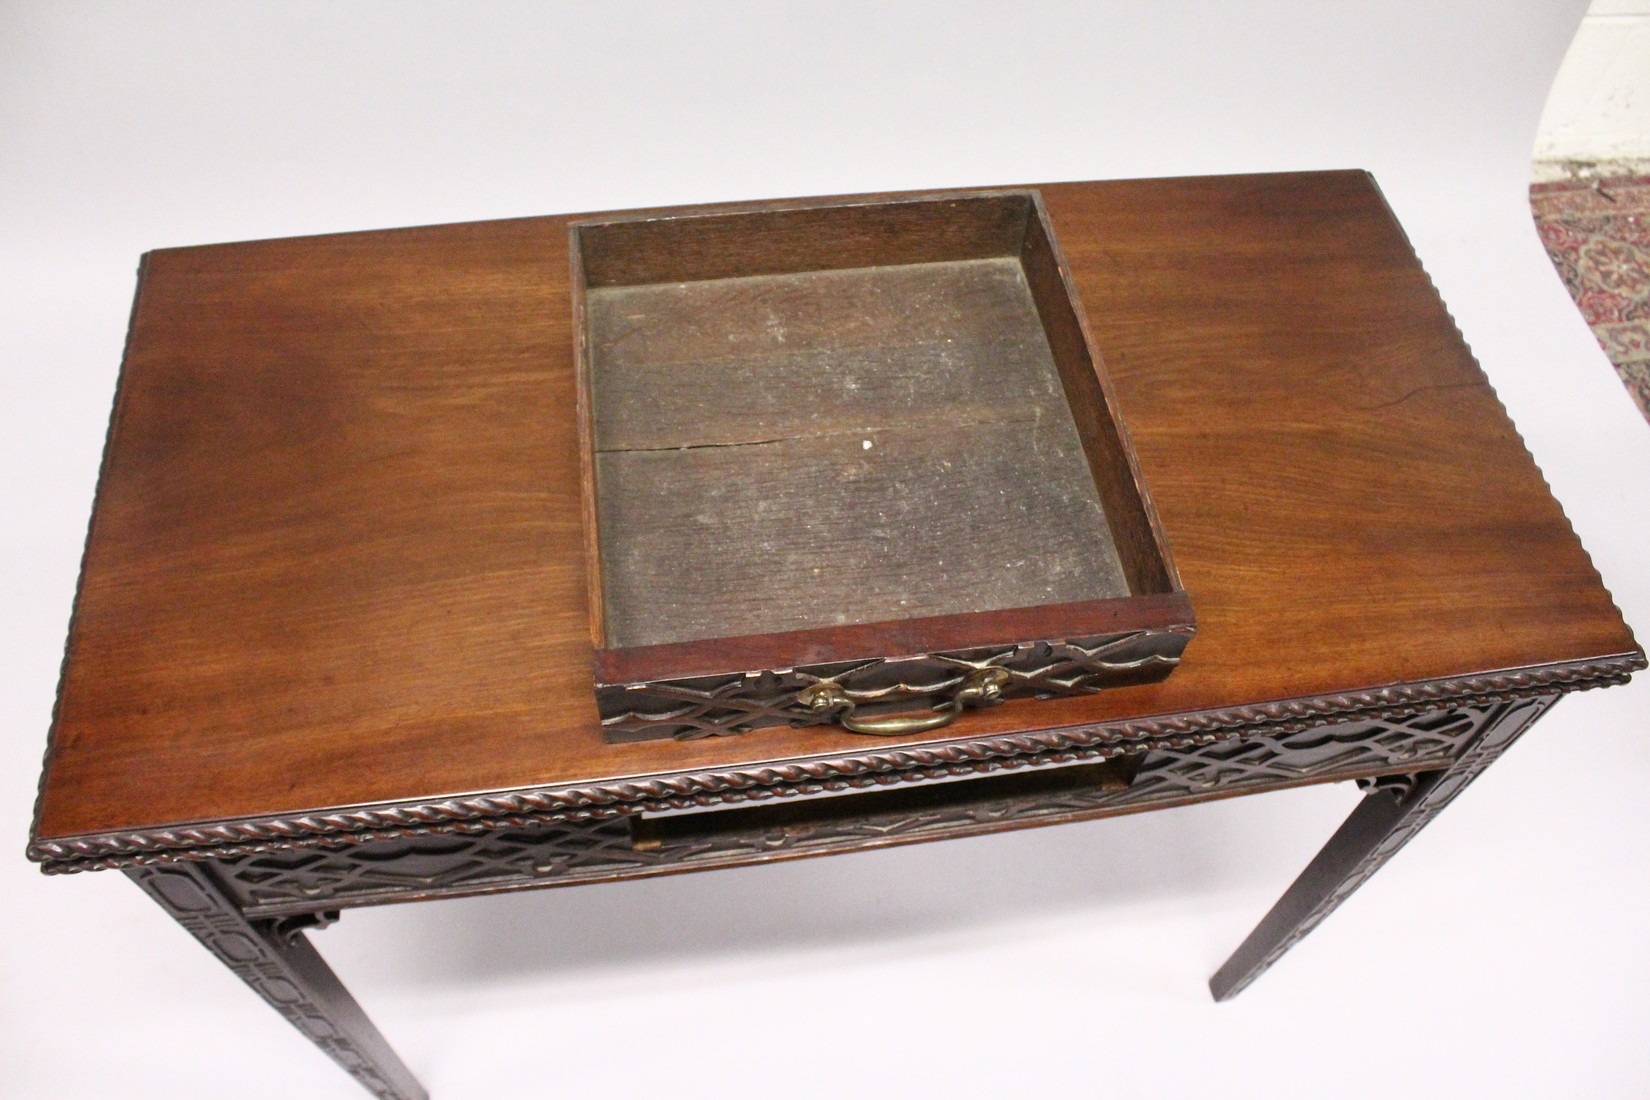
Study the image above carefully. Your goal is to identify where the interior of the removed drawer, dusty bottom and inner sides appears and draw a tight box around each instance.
[576,193,1170,648]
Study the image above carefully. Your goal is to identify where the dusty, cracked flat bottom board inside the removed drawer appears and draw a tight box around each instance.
[587,257,1129,653]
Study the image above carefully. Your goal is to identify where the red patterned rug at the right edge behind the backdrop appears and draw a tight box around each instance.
[1530,176,1650,421]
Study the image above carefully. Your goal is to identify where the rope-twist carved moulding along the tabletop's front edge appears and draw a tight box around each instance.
[28,651,1645,874]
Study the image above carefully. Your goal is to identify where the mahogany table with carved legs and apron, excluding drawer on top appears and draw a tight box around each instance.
[28,172,1645,1098]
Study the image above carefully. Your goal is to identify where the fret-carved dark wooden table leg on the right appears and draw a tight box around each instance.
[1209,696,1558,1001]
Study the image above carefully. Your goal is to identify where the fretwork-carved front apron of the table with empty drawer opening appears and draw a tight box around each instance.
[215,701,1511,917]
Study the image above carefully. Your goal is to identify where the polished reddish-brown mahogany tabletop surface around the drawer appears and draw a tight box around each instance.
[35,173,1635,838]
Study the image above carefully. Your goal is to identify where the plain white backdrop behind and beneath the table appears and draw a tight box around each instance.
[0,0,1650,1100]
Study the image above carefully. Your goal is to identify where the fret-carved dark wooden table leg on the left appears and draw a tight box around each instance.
[127,863,427,1100]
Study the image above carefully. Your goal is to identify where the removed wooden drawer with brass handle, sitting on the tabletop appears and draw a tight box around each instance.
[571,191,1193,740]
